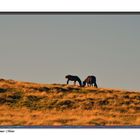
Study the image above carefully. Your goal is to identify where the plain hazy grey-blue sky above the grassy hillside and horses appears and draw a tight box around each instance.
[0,14,140,91]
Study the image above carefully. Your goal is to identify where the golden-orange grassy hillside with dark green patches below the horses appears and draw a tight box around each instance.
[0,79,140,126]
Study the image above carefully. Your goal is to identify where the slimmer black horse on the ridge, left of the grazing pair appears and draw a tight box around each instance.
[65,75,82,86]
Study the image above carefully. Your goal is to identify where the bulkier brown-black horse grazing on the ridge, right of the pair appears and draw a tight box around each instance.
[83,75,98,88]
